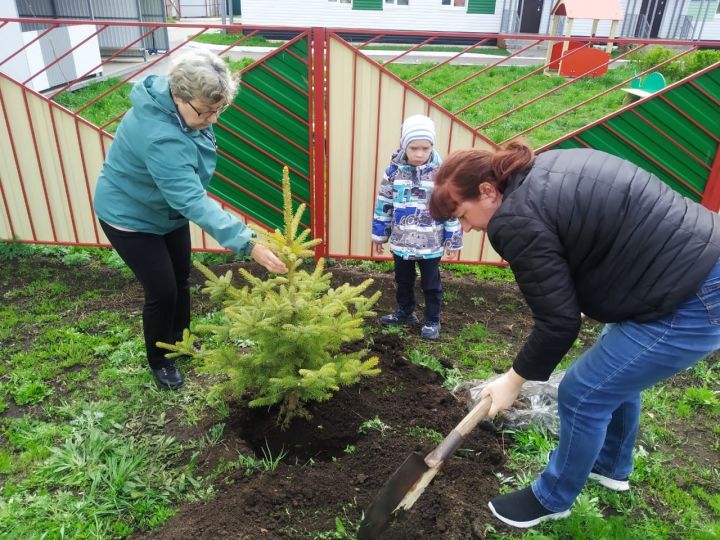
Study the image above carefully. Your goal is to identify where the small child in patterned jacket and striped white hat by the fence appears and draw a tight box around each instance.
[372,115,462,339]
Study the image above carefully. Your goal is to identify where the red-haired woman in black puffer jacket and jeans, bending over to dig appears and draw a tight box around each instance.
[430,143,720,527]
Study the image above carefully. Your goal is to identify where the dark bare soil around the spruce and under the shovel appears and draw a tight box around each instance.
[0,254,718,540]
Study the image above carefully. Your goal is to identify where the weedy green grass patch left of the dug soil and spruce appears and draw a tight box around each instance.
[0,242,256,539]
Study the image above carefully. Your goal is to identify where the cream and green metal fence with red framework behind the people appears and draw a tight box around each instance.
[0,18,720,264]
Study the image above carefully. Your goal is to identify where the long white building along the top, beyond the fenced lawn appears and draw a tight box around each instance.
[242,0,720,40]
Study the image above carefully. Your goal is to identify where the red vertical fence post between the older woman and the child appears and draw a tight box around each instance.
[310,28,328,259]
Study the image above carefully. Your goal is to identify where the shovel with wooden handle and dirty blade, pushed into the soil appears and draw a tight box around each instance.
[358,396,492,540]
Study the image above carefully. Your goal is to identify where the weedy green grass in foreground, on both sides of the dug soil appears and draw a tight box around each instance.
[0,243,720,540]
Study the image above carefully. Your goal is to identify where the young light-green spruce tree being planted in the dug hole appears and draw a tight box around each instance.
[159,167,380,428]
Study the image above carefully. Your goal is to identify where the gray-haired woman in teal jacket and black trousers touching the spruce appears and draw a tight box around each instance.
[94,51,287,389]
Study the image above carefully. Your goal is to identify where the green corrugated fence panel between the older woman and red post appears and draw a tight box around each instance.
[209,37,311,229]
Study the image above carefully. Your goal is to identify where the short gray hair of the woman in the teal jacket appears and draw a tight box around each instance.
[168,49,238,104]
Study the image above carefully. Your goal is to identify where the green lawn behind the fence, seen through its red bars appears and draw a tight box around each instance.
[49,43,720,148]
